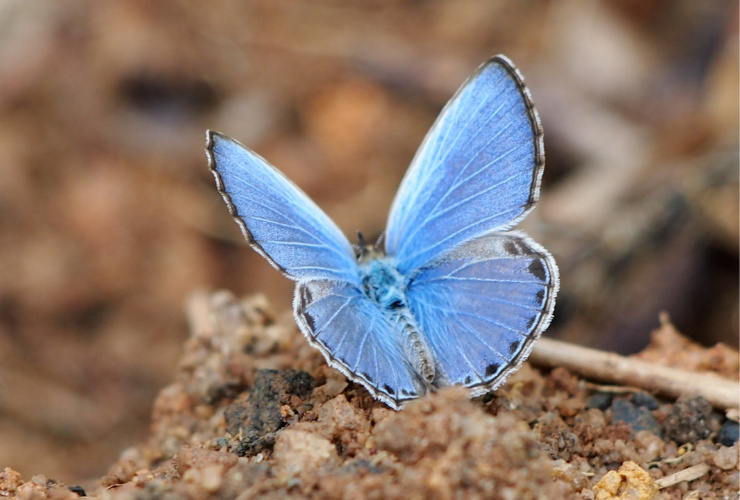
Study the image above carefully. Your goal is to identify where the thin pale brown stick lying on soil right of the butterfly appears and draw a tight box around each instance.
[529,338,740,409]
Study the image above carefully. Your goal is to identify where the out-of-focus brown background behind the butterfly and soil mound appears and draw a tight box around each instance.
[0,0,738,483]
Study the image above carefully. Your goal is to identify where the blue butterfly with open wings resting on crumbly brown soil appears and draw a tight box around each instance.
[206,55,559,409]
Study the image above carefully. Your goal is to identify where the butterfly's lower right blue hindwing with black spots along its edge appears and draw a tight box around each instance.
[407,232,559,395]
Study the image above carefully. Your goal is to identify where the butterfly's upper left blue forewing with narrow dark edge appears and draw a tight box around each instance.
[206,131,358,283]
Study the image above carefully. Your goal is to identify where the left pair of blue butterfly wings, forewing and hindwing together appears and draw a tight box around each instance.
[206,132,426,408]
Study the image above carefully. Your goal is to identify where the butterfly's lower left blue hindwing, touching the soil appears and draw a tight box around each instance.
[293,280,425,409]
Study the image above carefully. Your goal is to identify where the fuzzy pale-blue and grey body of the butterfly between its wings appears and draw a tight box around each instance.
[357,252,436,385]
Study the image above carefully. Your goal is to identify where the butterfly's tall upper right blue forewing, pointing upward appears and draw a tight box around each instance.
[386,56,545,273]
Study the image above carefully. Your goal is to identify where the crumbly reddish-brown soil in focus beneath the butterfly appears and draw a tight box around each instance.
[0,292,740,500]
